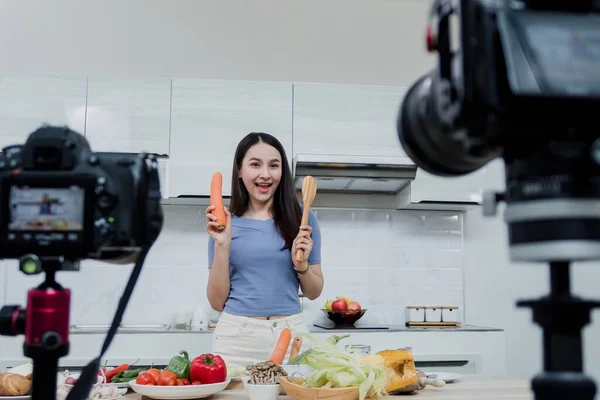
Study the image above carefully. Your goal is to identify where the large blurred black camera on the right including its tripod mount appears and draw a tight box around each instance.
[397,0,600,400]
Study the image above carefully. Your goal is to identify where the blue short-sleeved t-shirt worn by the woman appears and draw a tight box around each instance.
[208,211,321,317]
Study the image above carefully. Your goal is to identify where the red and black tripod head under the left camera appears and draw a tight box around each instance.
[0,255,72,400]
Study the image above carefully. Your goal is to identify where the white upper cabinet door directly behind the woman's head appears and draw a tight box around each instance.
[168,79,292,197]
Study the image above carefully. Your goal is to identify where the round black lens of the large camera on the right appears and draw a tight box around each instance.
[397,72,495,176]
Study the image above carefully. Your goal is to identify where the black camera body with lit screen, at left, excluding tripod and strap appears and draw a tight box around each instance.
[0,127,163,262]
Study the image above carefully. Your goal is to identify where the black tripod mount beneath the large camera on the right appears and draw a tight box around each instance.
[517,261,600,400]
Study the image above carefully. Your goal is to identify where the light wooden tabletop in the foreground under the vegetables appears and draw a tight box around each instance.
[122,375,534,400]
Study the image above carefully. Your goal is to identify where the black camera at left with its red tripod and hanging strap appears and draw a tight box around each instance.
[0,126,163,400]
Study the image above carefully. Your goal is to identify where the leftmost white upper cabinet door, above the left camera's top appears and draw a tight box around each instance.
[0,75,87,148]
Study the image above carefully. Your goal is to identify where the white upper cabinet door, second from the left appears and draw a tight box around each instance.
[85,77,171,198]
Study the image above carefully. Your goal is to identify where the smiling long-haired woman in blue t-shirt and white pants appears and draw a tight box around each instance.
[206,133,323,366]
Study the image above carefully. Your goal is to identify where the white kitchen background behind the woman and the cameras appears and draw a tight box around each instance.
[0,0,600,398]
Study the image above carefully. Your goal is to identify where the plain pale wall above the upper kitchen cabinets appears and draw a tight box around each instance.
[0,0,434,85]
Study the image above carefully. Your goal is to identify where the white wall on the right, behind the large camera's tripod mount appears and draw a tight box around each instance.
[464,161,600,384]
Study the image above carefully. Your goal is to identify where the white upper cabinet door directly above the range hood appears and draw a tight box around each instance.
[294,83,406,157]
